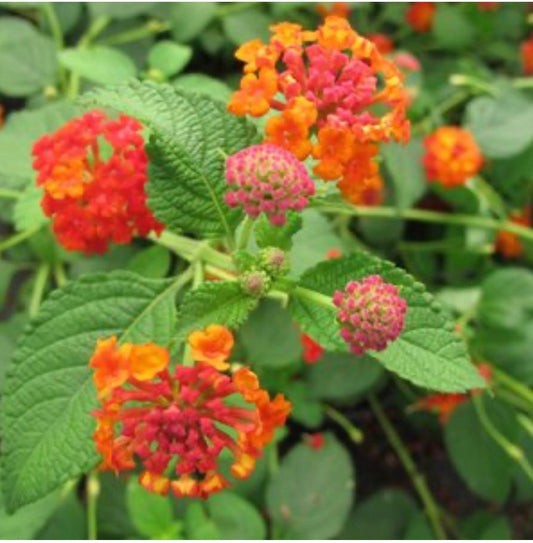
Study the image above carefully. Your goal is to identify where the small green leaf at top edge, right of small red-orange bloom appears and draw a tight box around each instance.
[433,4,476,50]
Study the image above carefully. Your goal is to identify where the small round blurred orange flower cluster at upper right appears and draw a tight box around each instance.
[423,126,483,188]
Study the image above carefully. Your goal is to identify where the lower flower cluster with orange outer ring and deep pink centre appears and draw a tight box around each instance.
[90,327,290,498]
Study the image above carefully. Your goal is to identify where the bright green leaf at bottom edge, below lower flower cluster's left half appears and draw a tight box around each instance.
[126,479,181,539]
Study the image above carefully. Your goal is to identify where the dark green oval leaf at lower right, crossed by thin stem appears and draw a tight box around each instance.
[444,400,518,503]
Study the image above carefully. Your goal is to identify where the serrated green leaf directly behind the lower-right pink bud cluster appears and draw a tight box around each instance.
[289,253,485,392]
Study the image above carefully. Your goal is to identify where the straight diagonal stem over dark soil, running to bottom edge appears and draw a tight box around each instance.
[368,395,446,539]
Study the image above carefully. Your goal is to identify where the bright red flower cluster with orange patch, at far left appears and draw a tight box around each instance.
[33,111,163,254]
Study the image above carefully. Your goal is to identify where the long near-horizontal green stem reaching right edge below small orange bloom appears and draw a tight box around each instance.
[312,201,533,240]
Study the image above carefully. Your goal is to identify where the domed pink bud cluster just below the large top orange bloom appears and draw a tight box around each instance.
[226,144,315,226]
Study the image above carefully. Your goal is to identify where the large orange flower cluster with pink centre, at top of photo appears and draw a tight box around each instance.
[228,16,409,204]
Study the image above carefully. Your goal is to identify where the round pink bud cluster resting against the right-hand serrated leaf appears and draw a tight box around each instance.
[333,275,407,356]
